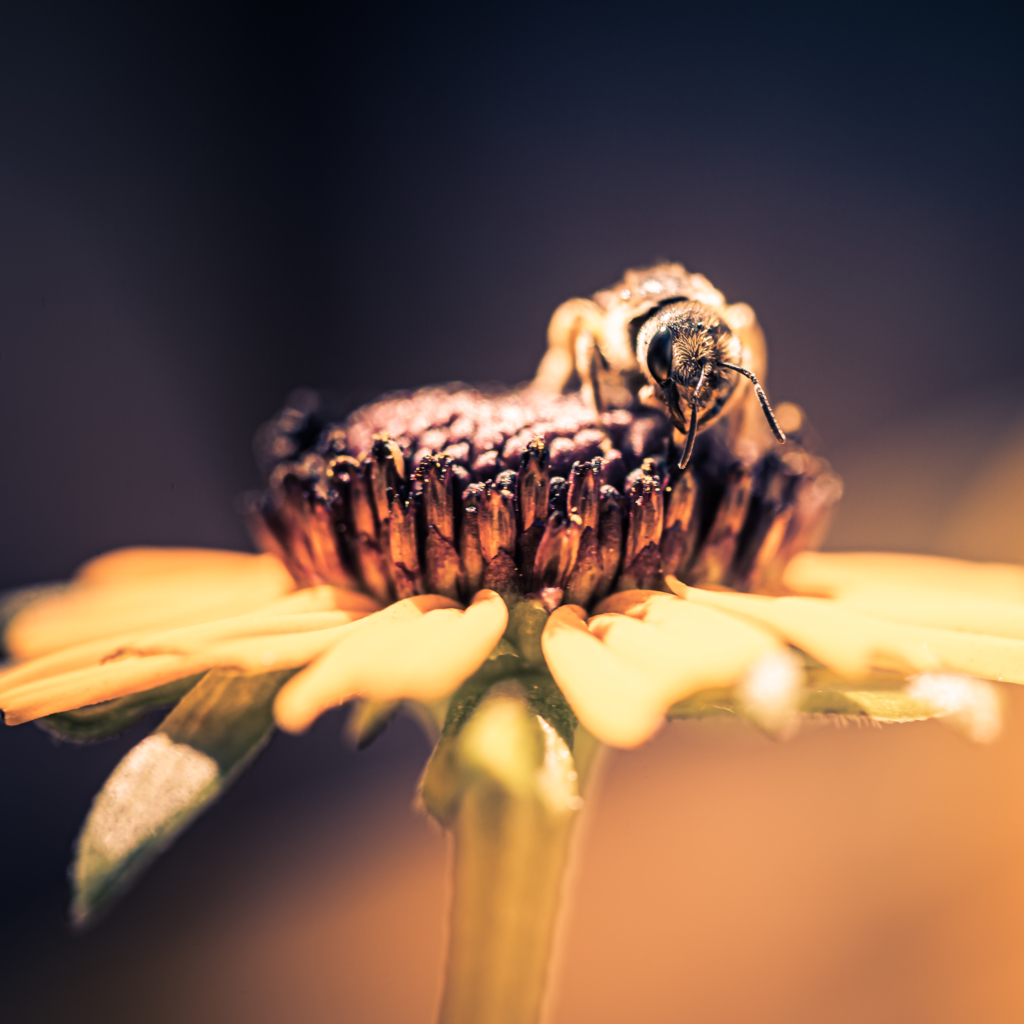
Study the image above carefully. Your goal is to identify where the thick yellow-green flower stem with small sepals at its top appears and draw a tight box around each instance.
[422,674,598,1024]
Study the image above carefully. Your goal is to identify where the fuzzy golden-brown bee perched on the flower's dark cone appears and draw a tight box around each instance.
[534,263,785,469]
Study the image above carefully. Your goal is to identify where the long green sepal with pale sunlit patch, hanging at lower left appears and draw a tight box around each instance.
[72,669,294,926]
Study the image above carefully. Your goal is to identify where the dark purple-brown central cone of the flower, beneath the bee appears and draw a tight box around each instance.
[252,387,841,608]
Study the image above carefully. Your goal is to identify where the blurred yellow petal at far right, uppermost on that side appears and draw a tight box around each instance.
[782,551,1024,603]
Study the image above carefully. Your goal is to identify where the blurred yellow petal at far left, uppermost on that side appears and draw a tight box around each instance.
[4,552,295,660]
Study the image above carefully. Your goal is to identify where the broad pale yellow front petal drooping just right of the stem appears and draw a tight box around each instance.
[541,591,781,748]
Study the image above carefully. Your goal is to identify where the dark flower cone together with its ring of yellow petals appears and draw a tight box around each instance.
[6,386,1024,746]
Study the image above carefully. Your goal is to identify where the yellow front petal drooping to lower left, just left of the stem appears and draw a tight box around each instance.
[274,590,508,732]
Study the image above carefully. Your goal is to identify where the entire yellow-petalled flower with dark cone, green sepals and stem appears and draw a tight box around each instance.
[0,387,1024,1021]
